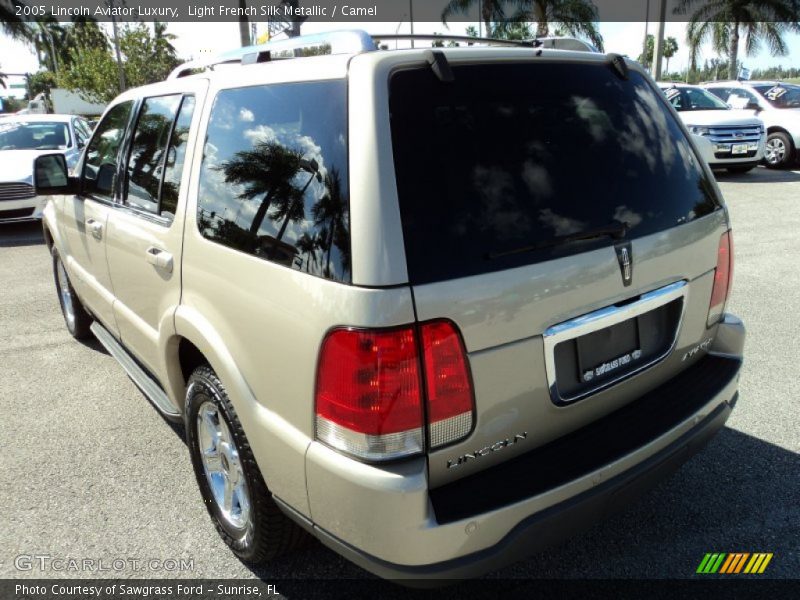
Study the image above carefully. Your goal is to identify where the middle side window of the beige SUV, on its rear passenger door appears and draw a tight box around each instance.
[127,95,181,213]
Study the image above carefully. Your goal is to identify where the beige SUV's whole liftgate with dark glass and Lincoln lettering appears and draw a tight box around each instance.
[390,59,727,487]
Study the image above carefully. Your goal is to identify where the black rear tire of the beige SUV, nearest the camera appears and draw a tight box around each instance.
[185,366,306,563]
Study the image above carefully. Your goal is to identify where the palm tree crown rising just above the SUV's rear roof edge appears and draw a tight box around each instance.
[518,0,603,52]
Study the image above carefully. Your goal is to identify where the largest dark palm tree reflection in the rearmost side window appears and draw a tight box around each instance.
[217,142,303,236]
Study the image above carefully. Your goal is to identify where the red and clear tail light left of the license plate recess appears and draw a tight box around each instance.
[315,321,474,461]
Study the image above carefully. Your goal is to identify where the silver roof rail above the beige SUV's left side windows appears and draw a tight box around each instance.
[167,29,377,79]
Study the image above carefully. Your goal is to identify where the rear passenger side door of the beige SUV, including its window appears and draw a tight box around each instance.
[107,81,206,375]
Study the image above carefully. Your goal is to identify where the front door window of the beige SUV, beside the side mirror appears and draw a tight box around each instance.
[83,102,133,199]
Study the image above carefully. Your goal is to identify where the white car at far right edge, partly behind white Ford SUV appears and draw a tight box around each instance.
[703,81,800,168]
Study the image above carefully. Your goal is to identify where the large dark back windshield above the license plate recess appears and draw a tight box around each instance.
[390,63,719,284]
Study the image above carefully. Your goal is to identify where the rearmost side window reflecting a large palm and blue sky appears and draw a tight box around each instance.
[198,81,350,281]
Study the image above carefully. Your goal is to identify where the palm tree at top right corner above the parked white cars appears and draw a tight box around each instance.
[675,0,800,79]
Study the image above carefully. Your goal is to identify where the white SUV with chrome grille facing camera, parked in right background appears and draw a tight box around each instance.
[658,83,766,173]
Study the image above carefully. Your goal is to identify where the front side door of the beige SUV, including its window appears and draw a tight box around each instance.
[58,100,134,335]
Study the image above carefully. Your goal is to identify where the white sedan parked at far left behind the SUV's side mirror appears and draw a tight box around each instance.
[0,115,91,222]
